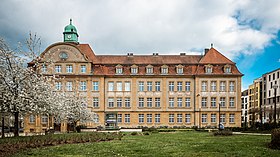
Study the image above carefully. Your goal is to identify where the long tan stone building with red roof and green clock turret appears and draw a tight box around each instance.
[25,21,243,132]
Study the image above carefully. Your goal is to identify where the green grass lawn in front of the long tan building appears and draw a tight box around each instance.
[15,131,280,157]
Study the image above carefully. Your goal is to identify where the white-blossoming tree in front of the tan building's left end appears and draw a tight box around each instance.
[0,34,95,136]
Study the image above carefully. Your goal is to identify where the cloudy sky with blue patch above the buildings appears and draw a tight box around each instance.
[0,0,280,90]
